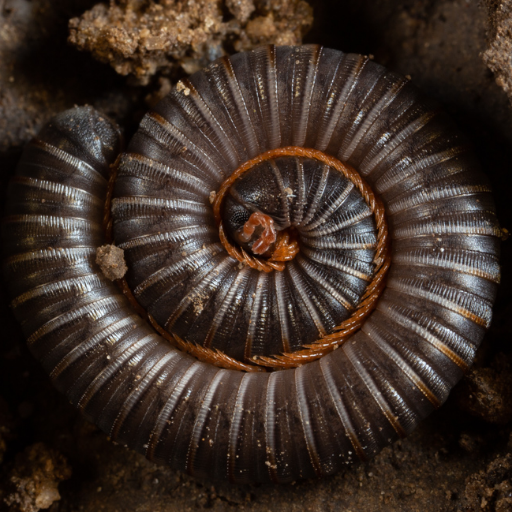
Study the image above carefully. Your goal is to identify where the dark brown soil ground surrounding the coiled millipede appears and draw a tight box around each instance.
[0,0,512,512]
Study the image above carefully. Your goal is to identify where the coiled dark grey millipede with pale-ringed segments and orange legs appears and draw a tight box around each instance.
[3,46,500,483]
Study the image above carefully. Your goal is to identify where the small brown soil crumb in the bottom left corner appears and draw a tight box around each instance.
[4,443,71,512]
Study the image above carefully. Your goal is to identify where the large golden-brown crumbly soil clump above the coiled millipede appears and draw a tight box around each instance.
[69,0,313,83]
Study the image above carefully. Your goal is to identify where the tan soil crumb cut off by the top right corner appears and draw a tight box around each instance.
[482,0,512,101]
